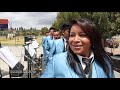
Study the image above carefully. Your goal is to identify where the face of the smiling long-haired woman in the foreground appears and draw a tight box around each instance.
[69,24,91,57]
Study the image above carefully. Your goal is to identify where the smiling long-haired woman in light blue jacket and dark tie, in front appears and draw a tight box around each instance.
[40,19,114,78]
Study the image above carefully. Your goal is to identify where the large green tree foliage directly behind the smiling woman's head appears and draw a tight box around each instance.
[52,12,120,39]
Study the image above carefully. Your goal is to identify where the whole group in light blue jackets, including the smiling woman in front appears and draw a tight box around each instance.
[39,19,115,78]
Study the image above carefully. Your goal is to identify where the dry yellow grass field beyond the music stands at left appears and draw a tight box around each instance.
[0,36,42,46]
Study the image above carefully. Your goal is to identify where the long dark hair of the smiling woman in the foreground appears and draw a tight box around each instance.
[68,19,112,77]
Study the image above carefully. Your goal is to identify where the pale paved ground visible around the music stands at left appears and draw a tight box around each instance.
[0,46,43,78]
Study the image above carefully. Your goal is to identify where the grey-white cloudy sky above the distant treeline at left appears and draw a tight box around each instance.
[0,12,57,29]
